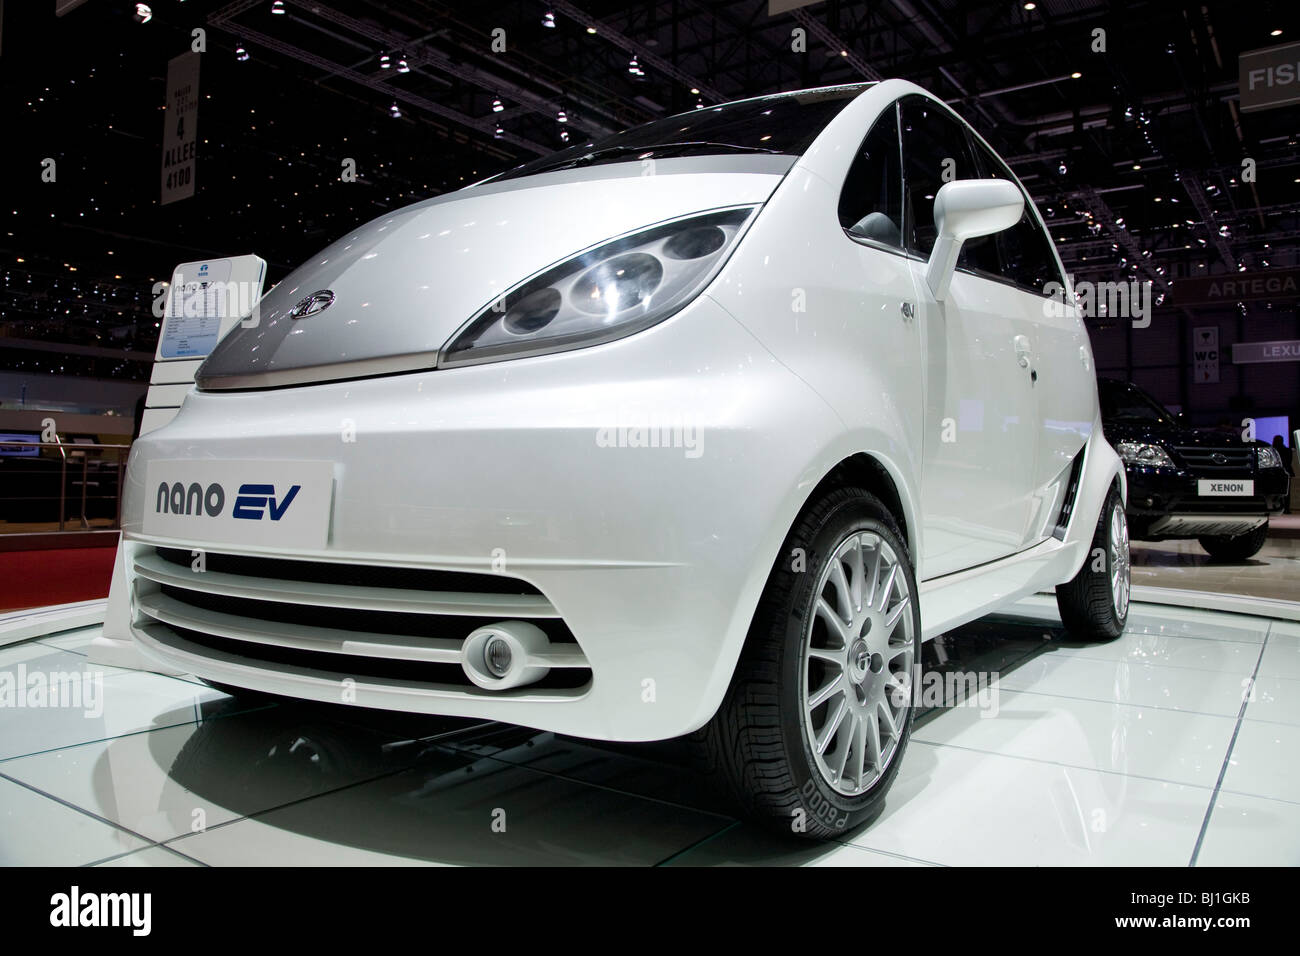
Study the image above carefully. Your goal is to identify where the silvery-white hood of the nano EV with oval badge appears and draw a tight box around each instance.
[195,156,793,390]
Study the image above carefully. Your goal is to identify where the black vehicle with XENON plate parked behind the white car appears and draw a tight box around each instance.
[1097,378,1287,561]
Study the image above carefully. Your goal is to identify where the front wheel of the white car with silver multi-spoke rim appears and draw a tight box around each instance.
[701,488,922,839]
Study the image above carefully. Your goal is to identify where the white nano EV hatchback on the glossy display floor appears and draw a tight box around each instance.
[116,81,1128,835]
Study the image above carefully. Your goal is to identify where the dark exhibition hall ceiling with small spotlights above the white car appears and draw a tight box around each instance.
[0,0,1300,376]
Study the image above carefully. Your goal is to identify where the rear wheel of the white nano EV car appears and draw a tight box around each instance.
[1056,488,1131,641]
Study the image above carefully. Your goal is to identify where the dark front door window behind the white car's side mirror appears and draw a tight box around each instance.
[902,96,997,274]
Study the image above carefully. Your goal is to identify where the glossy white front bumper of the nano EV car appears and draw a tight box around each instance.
[114,298,842,740]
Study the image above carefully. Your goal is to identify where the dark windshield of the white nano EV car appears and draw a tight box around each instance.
[493,83,871,182]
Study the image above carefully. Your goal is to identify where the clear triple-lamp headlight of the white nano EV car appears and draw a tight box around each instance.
[438,206,755,367]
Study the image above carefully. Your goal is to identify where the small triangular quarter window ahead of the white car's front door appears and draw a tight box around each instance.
[840,105,902,248]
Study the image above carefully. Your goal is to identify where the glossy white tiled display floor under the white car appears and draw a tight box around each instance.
[0,597,1300,866]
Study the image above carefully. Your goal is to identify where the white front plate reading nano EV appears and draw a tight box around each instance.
[142,460,334,549]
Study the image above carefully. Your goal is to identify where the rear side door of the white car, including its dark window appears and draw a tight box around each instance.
[970,130,1096,544]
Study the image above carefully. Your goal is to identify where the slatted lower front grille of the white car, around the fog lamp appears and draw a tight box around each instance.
[131,548,592,697]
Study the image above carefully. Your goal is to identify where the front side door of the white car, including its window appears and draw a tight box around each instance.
[900,96,1036,578]
